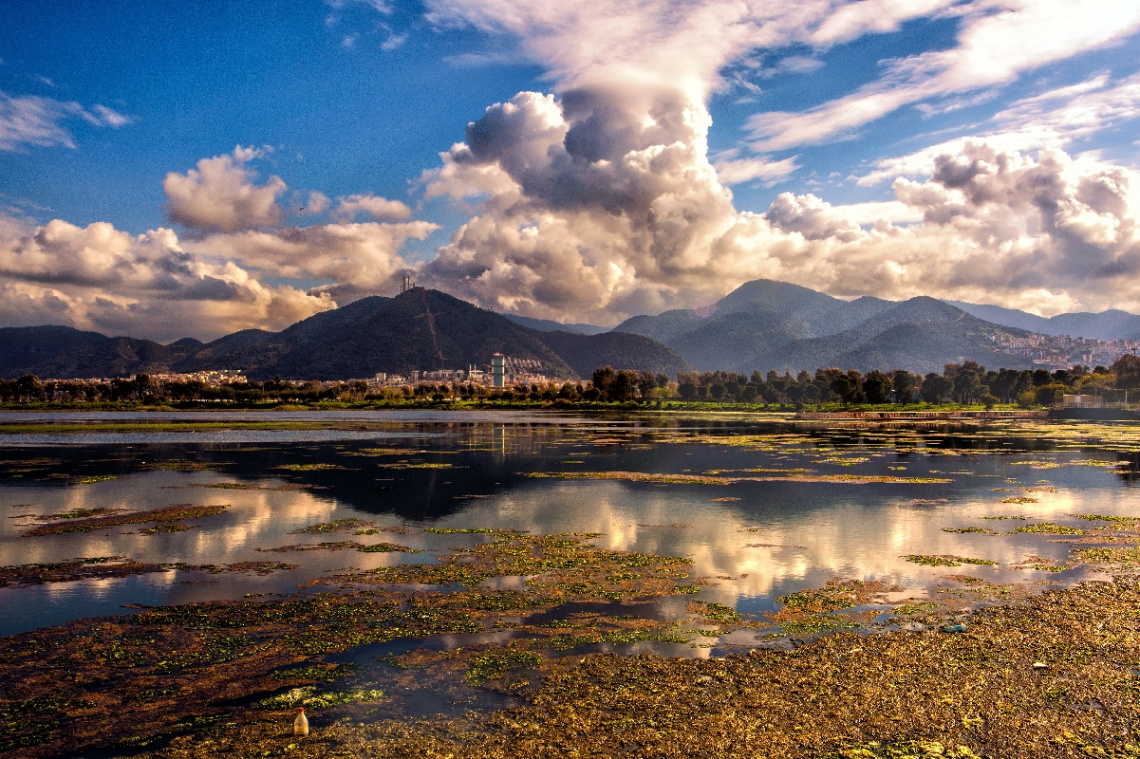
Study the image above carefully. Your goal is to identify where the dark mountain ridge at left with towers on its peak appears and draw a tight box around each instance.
[0,288,692,380]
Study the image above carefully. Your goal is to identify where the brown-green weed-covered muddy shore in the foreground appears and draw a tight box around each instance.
[0,533,1140,759]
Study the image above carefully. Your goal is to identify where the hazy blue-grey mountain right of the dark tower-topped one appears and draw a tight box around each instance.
[616,279,1028,373]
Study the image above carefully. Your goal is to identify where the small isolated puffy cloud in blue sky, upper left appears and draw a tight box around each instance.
[162,146,285,232]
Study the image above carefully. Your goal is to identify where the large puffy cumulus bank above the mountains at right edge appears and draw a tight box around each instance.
[738,142,1140,315]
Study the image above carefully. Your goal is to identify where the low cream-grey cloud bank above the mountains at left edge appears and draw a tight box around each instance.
[0,213,336,340]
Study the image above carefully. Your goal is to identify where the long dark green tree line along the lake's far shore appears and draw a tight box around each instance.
[0,354,1140,407]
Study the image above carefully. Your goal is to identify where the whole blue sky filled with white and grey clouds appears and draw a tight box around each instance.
[0,0,1140,342]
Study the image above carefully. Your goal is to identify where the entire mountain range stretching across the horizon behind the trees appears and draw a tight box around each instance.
[0,279,1140,380]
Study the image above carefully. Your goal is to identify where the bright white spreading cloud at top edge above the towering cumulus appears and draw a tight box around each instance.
[426,0,954,101]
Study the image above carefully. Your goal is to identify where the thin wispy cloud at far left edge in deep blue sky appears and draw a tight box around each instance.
[0,91,133,150]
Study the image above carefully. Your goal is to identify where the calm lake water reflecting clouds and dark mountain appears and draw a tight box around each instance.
[0,411,1140,633]
